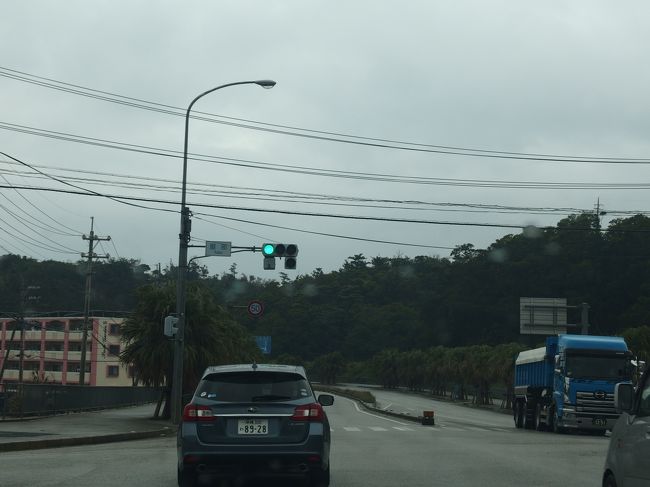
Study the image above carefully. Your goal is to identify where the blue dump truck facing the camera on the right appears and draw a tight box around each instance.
[513,335,632,434]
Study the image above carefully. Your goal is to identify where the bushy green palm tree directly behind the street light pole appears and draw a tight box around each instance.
[120,281,261,418]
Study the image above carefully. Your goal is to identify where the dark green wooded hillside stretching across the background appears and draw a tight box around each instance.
[0,213,650,412]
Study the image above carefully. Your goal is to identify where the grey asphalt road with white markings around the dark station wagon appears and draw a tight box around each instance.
[0,393,607,487]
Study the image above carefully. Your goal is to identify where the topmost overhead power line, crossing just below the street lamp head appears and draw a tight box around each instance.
[0,66,650,164]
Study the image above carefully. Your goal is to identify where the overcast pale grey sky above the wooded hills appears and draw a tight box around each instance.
[0,0,650,278]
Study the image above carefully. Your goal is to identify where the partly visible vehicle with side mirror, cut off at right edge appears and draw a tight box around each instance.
[603,372,650,487]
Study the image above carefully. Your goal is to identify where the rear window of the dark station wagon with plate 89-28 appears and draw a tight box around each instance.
[196,371,312,402]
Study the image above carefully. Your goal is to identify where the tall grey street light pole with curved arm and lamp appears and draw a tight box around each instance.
[171,80,275,424]
